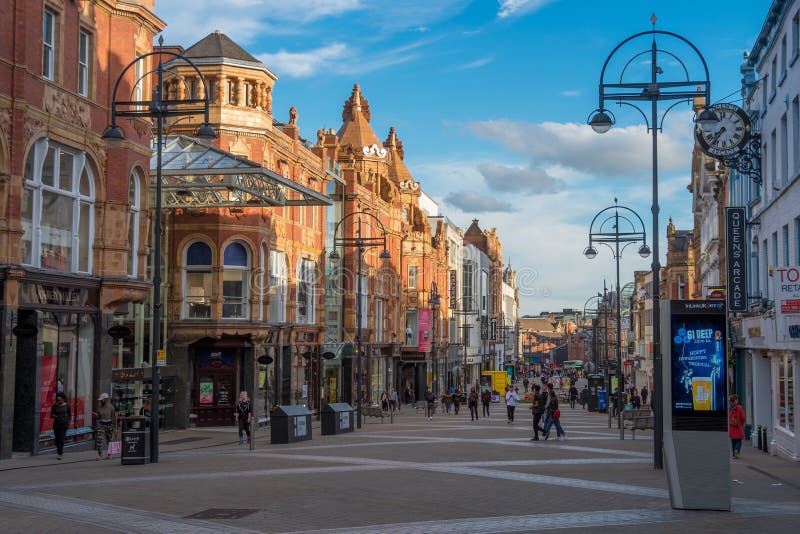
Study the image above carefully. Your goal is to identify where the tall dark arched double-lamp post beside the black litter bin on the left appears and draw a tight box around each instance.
[103,37,217,463]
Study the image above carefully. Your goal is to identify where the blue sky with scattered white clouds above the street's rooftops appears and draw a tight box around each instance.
[156,0,770,313]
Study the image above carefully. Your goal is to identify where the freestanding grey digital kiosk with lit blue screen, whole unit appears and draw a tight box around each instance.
[661,300,731,510]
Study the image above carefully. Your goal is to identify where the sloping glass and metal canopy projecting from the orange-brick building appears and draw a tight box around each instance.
[150,135,333,209]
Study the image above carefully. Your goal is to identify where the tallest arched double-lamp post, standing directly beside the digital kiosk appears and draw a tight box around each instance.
[588,14,719,469]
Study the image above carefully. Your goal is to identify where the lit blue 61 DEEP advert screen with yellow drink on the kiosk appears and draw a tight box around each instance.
[672,315,726,413]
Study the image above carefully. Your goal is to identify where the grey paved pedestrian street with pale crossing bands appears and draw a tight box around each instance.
[0,405,800,534]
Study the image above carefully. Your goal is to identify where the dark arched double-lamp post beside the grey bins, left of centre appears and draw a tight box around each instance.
[328,211,391,428]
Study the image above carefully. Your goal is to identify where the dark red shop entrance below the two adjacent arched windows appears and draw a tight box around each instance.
[192,349,237,426]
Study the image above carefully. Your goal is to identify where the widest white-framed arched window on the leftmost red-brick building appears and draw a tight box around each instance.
[21,139,94,273]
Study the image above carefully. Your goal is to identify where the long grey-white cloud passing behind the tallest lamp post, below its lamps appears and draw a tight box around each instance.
[467,120,691,177]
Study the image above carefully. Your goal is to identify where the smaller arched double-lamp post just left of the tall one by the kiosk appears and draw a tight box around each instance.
[583,198,650,439]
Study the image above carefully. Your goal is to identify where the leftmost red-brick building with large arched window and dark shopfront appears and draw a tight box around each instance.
[0,0,164,458]
